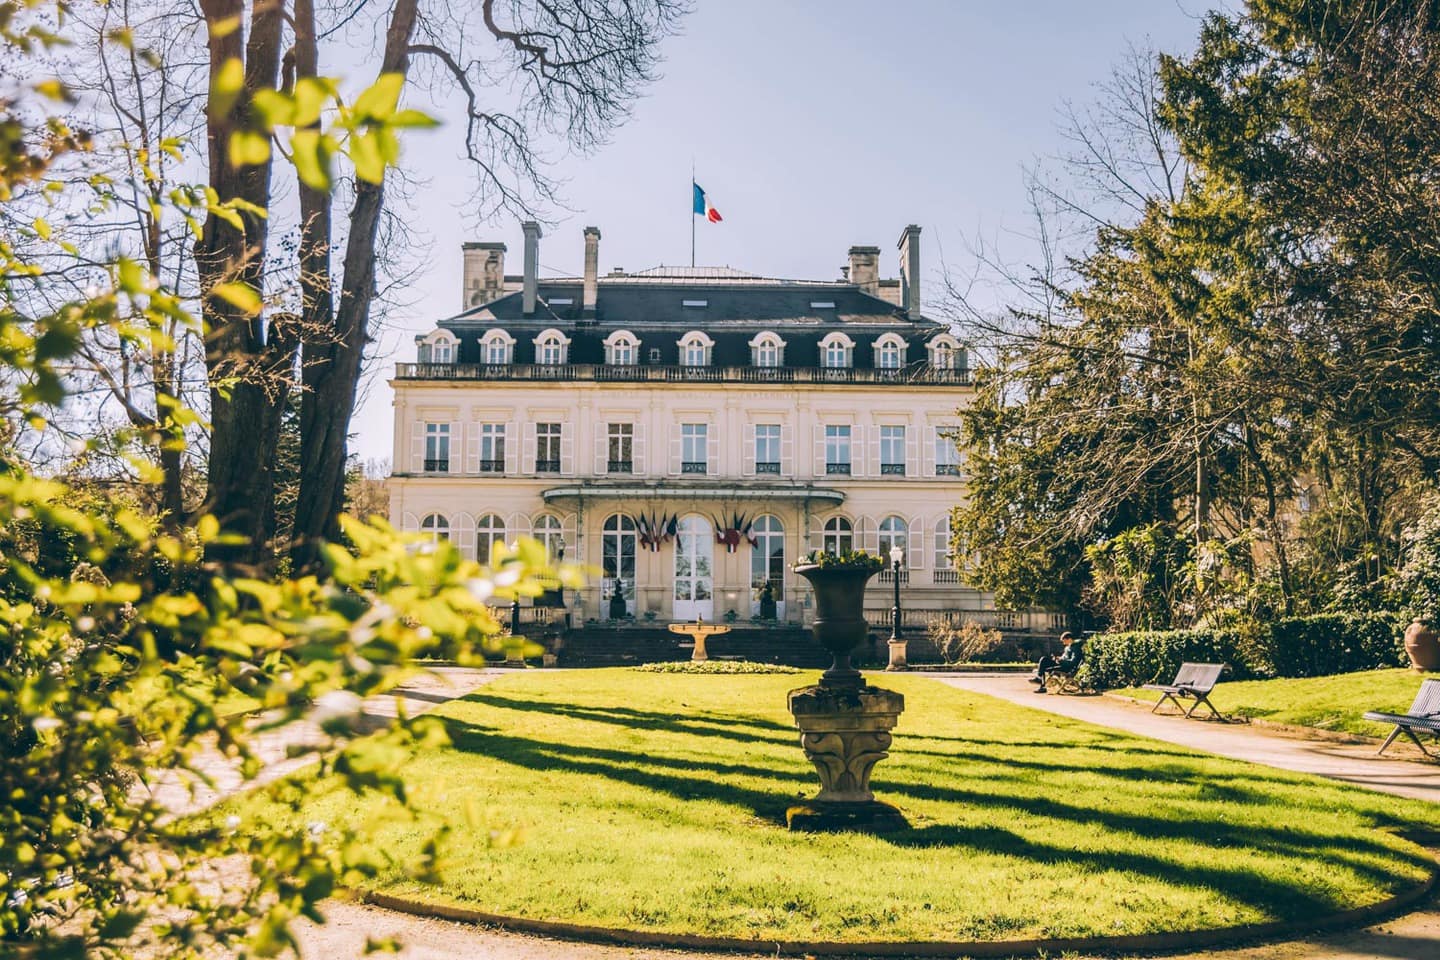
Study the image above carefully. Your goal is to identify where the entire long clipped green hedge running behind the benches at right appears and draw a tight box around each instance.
[1086,612,1408,688]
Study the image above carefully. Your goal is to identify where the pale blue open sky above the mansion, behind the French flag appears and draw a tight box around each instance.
[353,0,1217,458]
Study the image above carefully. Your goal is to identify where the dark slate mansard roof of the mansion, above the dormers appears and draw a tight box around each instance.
[426,268,946,368]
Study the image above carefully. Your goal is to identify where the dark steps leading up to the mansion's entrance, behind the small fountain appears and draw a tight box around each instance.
[559,623,829,669]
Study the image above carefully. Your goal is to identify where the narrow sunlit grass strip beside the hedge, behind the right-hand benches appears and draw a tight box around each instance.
[1115,669,1424,737]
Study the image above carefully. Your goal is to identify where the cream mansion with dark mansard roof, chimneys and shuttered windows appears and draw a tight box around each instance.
[392,223,1008,622]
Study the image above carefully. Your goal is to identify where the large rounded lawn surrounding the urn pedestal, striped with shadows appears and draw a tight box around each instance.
[217,669,1433,941]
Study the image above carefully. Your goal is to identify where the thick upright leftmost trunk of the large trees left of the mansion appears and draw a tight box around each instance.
[196,0,294,563]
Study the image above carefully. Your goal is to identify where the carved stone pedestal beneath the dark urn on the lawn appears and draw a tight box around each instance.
[785,687,907,830]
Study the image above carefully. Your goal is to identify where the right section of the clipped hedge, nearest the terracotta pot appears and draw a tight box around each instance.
[1248,612,1408,676]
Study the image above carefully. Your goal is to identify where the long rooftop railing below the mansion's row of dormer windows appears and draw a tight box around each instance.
[395,363,971,386]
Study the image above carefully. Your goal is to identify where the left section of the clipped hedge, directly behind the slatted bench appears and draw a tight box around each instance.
[1084,630,1254,688]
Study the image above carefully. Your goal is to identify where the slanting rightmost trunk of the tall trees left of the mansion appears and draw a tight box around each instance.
[291,0,418,570]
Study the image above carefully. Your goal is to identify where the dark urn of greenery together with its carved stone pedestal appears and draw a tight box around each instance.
[785,564,907,832]
